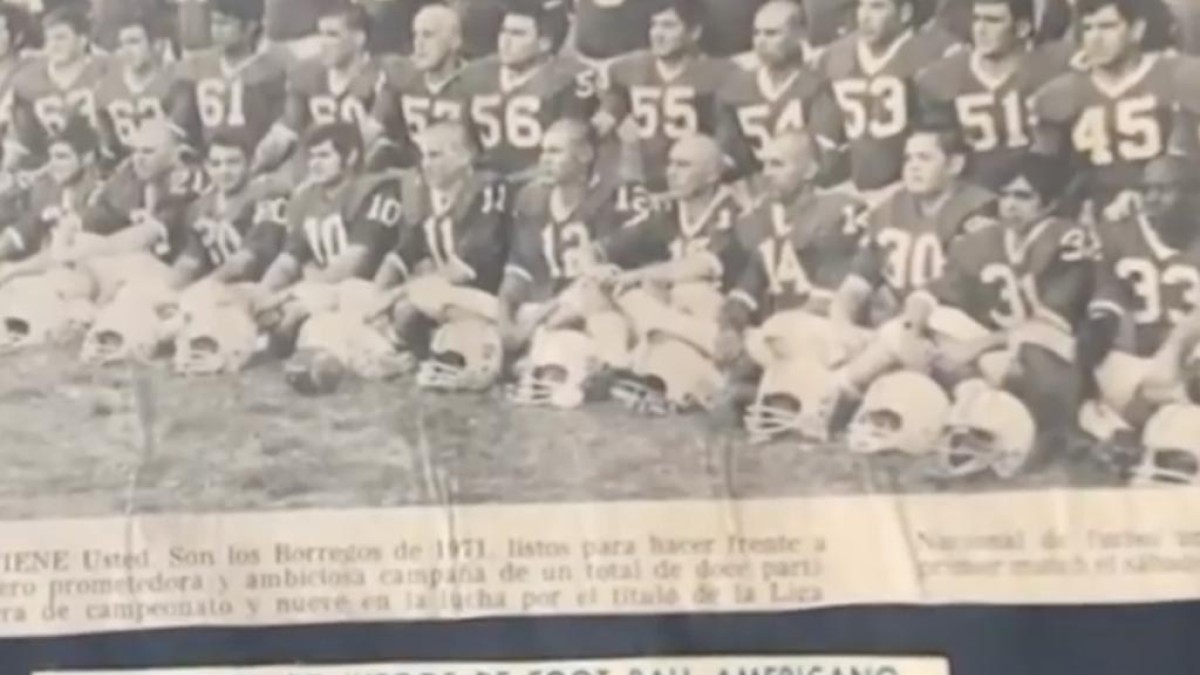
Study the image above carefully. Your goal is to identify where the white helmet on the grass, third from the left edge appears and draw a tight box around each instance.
[173,304,258,376]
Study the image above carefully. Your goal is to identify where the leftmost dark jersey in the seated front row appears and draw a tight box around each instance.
[5,171,101,257]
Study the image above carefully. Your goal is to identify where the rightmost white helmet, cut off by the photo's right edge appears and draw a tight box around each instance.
[1130,404,1200,486]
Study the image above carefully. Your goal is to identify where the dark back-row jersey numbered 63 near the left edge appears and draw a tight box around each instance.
[12,56,109,154]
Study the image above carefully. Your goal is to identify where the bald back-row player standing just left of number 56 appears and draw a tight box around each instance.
[372,4,463,166]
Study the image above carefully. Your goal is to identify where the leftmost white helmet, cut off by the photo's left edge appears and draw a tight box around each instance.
[0,269,95,352]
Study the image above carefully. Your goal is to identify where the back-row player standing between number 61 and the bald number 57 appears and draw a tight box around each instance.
[271,2,383,162]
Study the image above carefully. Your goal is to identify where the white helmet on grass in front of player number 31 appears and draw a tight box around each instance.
[937,380,1037,479]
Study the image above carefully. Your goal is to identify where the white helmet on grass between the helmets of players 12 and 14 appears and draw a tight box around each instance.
[612,336,722,416]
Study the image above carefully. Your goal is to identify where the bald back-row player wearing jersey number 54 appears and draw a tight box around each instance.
[721,0,842,166]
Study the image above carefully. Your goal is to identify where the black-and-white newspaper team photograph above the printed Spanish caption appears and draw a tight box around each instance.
[0,0,1200,520]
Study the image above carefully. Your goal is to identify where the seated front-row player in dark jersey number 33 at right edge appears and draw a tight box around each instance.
[1080,156,1200,440]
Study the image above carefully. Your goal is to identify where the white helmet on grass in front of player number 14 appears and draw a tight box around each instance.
[745,359,840,443]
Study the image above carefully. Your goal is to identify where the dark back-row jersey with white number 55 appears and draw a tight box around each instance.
[604,52,737,191]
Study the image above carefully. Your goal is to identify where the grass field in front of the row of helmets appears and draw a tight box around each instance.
[0,341,1118,519]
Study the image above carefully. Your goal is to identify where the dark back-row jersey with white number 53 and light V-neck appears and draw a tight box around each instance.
[820,29,955,191]
